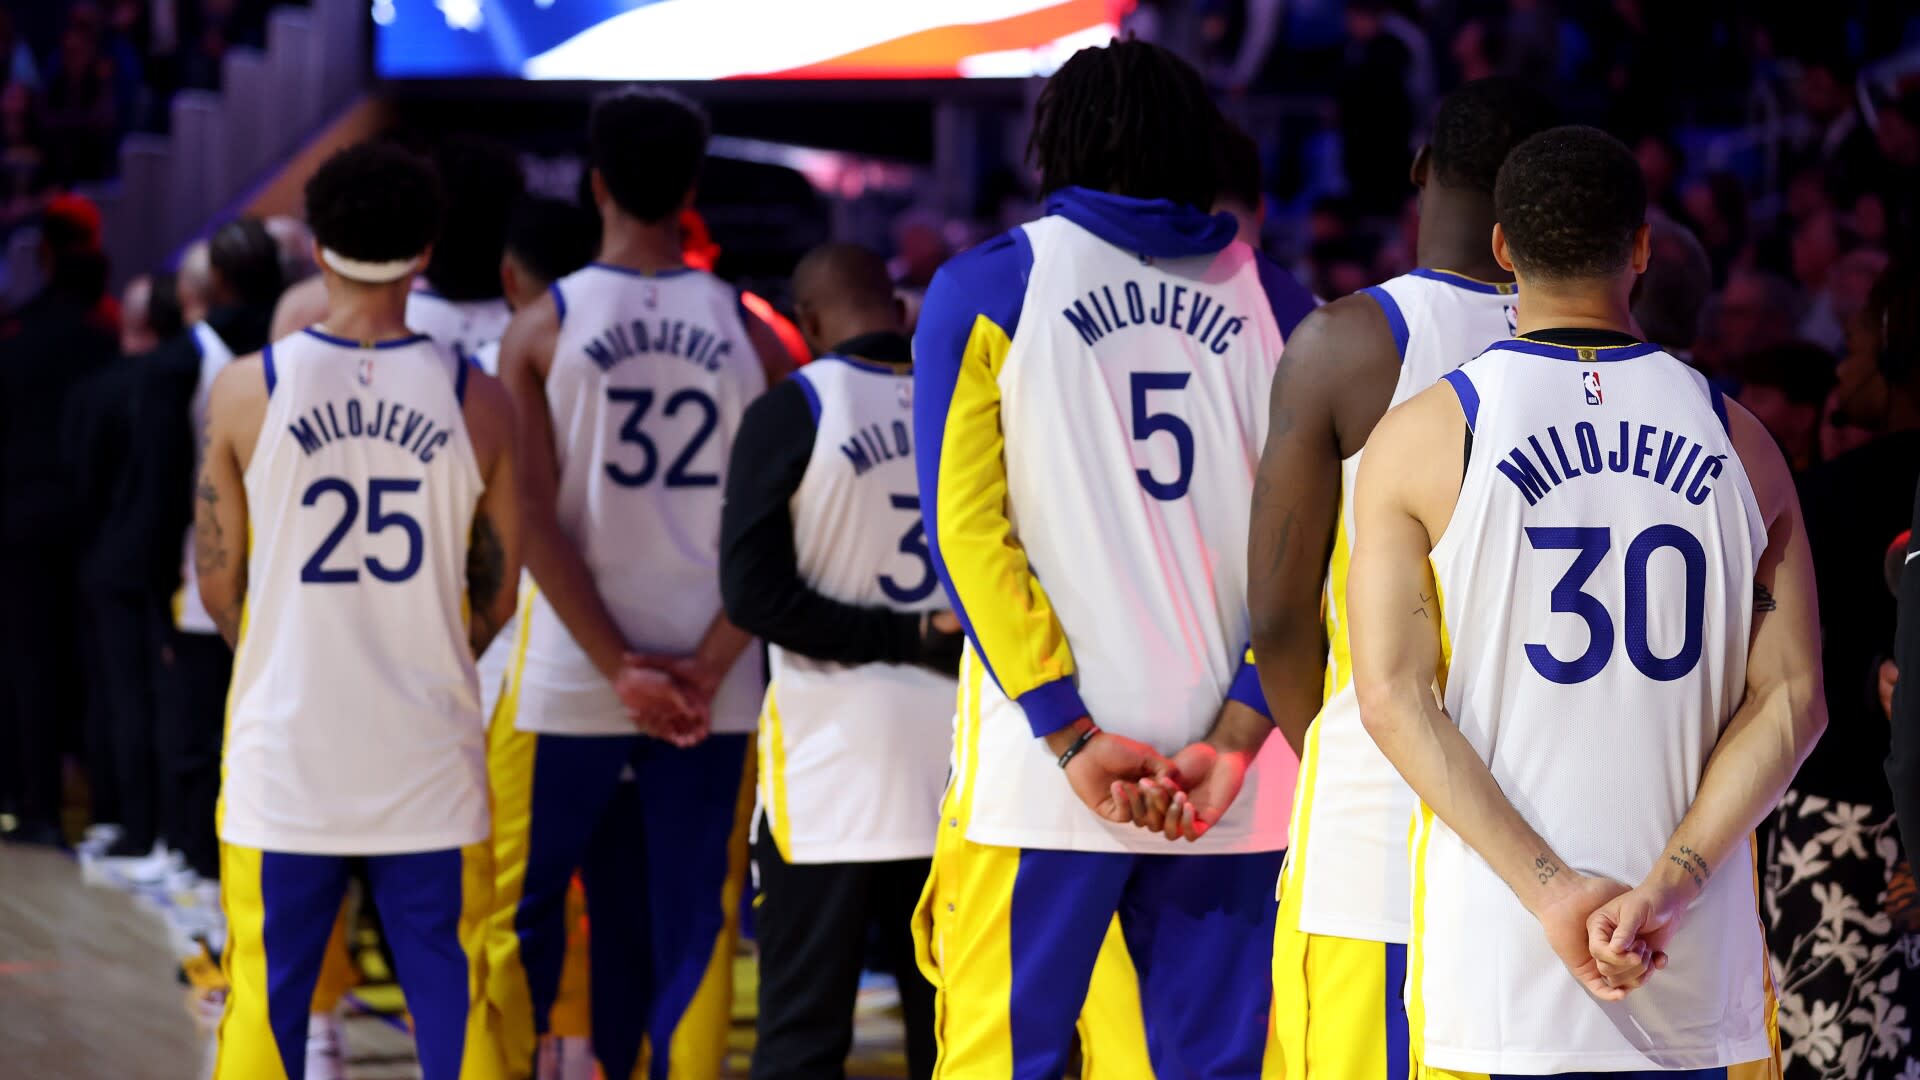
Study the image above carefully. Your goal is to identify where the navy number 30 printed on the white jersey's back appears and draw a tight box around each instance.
[1526,525,1707,686]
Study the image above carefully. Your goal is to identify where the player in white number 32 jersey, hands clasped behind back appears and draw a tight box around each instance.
[490,92,798,1078]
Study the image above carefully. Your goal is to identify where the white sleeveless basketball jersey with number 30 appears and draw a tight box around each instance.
[1407,340,1772,1072]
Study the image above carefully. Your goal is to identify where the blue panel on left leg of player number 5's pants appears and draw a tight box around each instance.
[1013,849,1135,1080]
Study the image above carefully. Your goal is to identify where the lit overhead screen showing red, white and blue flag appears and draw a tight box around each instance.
[372,0,1131,81]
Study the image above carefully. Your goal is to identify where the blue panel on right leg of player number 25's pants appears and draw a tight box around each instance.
[367,847,470,1076]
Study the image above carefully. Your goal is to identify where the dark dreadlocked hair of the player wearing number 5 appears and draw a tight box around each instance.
[1027,38,1225,209]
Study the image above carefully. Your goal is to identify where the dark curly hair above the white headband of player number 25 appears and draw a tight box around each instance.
[307,142,447,263]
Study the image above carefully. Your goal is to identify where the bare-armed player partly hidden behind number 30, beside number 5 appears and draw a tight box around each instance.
[1244,79,1551,1080]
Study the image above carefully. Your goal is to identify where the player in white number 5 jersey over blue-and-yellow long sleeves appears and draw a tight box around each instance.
[914,40,1311,1078]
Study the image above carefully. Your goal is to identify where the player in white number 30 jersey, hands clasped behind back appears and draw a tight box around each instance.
[1350,127,1826,1078]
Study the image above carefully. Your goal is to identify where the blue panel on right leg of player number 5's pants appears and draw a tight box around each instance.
[1119,851,1286,1080]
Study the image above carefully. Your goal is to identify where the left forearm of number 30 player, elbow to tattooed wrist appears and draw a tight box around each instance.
[1359,676,1574,911]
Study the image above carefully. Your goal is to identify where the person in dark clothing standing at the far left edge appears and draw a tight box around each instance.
[0,199,117,844]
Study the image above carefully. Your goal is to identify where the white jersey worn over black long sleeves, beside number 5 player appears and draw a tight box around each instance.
[756,356,960,863]
